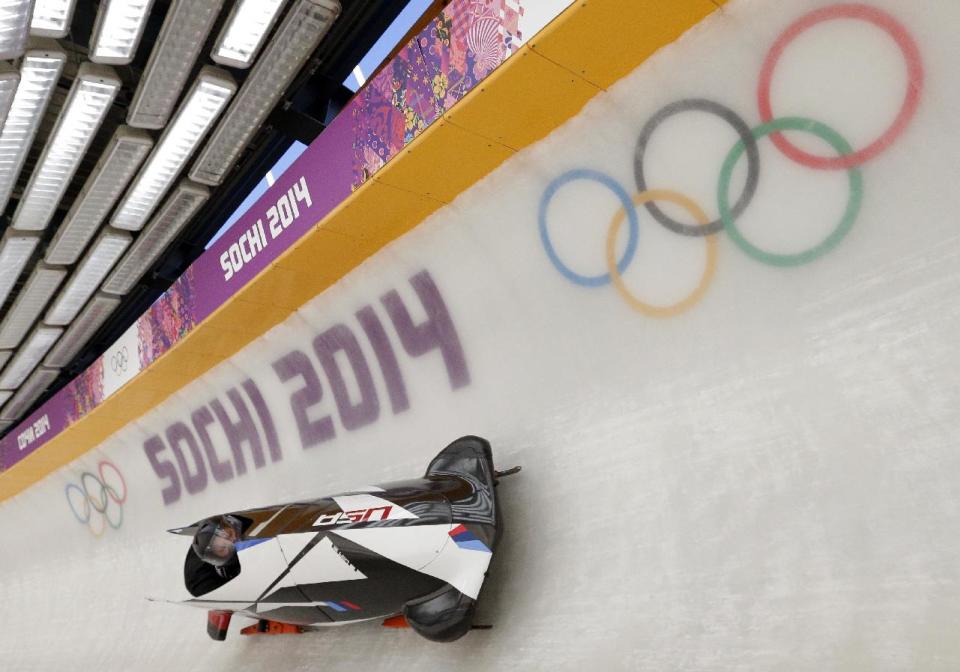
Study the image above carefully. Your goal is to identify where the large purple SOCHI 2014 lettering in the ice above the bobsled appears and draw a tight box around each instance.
[143,271,470,505]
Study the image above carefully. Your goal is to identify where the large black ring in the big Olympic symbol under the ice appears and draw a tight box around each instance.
[633,98,760,236]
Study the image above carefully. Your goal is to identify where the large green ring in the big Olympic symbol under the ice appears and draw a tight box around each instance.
[717,117,863,266]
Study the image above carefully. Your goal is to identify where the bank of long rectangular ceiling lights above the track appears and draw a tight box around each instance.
[0,0,340,431]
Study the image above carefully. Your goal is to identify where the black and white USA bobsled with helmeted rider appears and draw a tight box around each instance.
[162,436,519,642]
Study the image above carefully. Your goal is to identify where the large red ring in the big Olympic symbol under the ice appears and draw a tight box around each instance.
[757,4,923,169]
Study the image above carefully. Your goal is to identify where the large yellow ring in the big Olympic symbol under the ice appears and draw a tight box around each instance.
[607,189,717,317]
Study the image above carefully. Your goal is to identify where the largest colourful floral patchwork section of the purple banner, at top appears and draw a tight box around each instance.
[352,0,523,189]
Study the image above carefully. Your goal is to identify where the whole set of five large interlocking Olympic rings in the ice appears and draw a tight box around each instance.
[538,4,923,317]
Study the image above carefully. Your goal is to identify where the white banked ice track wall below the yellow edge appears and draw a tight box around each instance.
[0,0,960,670]
